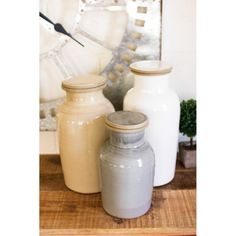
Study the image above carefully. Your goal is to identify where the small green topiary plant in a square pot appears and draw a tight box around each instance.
[179,99,197,168]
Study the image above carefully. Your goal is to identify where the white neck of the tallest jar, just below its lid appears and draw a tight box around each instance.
[134,74,169,93]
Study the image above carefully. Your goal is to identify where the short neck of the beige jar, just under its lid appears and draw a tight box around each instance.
[66,89,104,103]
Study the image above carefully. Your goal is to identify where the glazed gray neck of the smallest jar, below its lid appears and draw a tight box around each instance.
[110,130,145,148]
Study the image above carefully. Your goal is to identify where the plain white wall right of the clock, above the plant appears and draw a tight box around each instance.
[162,0,196,99]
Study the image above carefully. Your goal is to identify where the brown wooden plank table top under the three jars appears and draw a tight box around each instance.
[40,155,196,236]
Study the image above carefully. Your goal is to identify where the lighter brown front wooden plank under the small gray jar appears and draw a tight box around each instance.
[40,189,196,233]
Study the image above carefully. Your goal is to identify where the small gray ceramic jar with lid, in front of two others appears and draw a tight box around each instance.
[100,111,155,219]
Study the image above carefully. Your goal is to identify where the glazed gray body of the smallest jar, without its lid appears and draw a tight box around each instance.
[100,132,155,219]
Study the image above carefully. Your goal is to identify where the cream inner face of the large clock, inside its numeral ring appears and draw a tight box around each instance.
[40,0,128,102]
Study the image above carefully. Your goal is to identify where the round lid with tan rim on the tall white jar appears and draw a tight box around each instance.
[129,60,172,75]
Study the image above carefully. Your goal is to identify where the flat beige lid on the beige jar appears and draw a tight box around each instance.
[62,75,106,92]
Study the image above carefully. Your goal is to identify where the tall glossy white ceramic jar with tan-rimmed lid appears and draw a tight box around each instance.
[124,60,180,186]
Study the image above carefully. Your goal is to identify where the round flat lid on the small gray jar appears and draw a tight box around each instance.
[106,111,148,133]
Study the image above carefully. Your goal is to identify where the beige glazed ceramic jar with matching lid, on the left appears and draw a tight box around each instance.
[57,75,114,193]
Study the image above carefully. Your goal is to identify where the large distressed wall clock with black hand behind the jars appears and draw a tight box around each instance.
[40,0,161,131]
